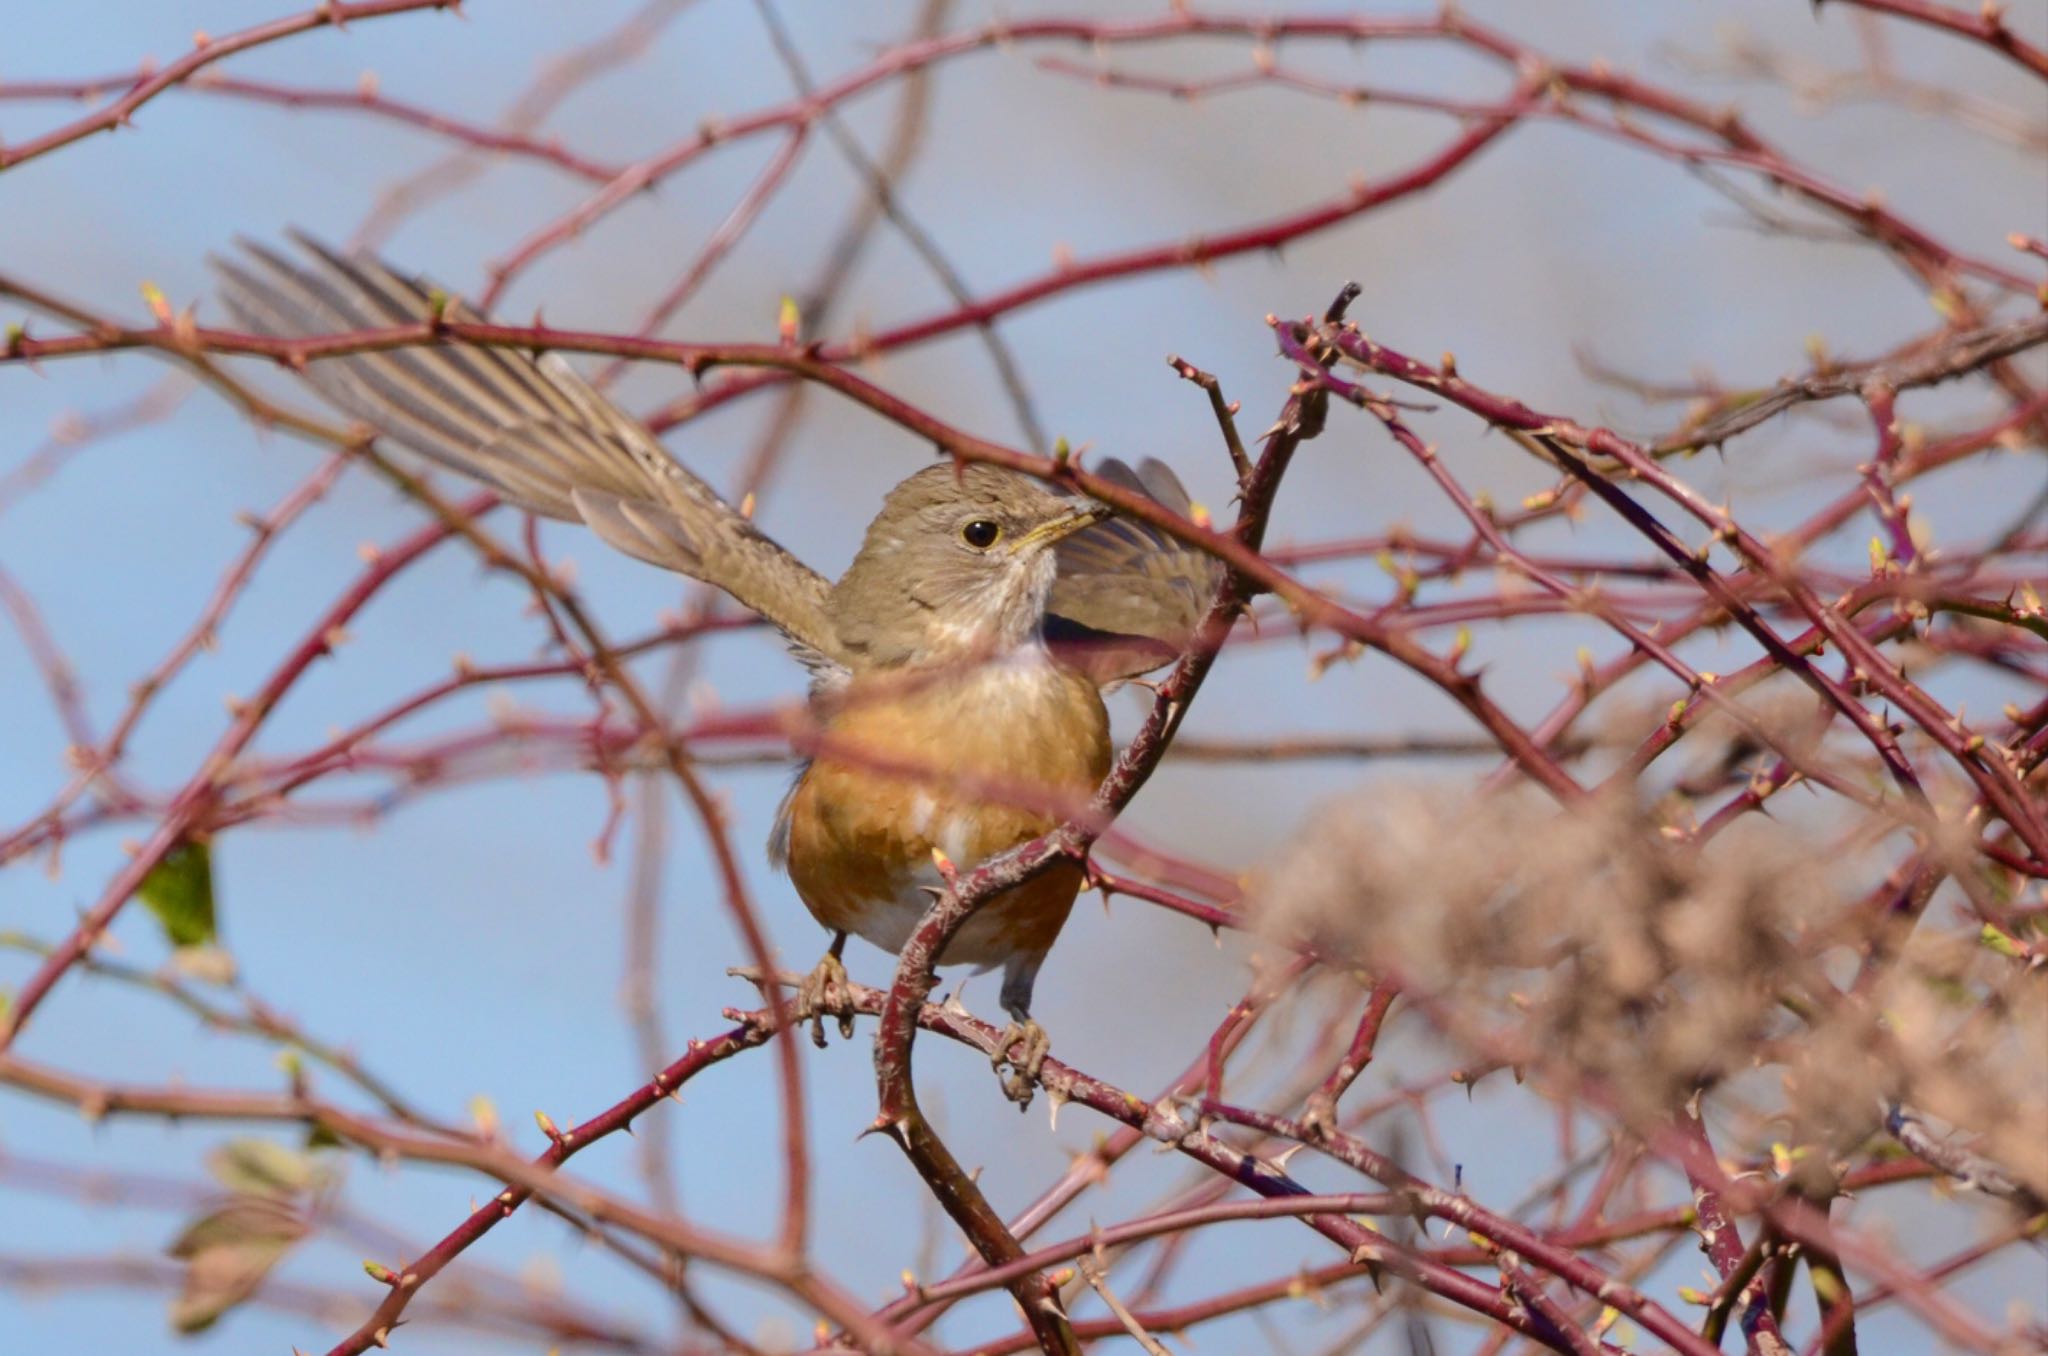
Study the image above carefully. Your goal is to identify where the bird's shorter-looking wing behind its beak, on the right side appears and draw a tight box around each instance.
[1047,457,1223,684]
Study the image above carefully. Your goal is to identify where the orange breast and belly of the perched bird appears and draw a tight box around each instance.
[784,653,1110,965]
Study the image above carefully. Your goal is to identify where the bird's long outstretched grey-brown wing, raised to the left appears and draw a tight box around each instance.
[213,234,842,678]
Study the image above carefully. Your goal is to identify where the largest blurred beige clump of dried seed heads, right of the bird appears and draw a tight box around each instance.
[1253,789,1874,1120]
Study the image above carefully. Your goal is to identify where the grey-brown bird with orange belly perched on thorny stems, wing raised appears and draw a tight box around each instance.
[213,231,1221,1102]
